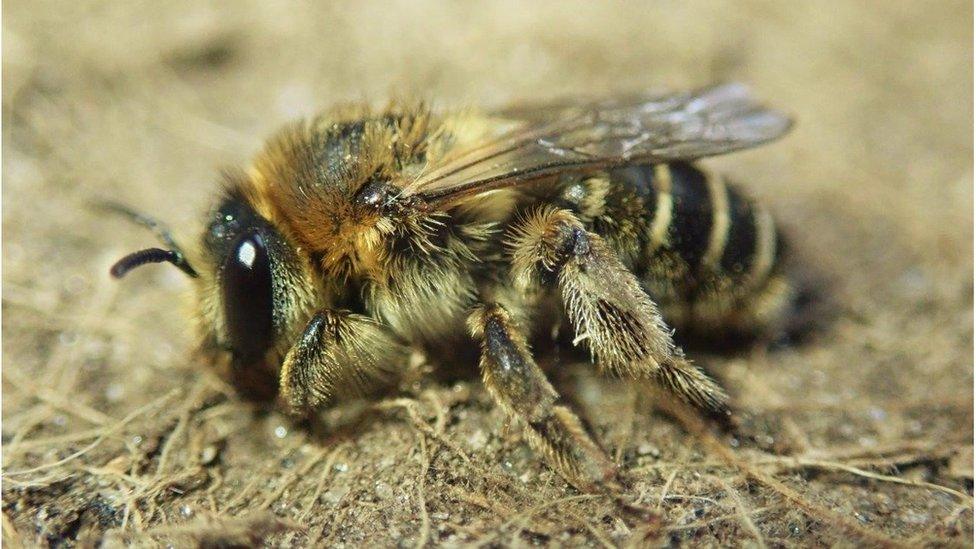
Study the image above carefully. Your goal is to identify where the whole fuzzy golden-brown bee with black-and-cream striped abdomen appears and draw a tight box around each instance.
[111,84,795,488]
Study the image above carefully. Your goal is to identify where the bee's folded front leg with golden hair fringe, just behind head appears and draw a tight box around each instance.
[280,311,409,413]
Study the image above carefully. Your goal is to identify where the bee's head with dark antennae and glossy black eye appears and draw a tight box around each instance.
[111,186,311,401]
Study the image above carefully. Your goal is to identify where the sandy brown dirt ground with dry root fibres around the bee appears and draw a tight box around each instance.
[2,0,973,547]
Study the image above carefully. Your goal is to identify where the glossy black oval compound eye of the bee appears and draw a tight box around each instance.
[221,232,274,362]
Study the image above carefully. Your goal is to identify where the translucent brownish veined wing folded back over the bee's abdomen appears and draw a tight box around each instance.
[403,84,791,205]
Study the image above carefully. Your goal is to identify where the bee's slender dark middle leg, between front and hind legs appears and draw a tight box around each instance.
[468,304,616,490]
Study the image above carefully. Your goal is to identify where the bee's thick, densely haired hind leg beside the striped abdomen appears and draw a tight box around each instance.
[510,207,727,411]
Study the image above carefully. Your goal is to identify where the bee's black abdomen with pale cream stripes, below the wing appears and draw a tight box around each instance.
[594,163,788,334]
